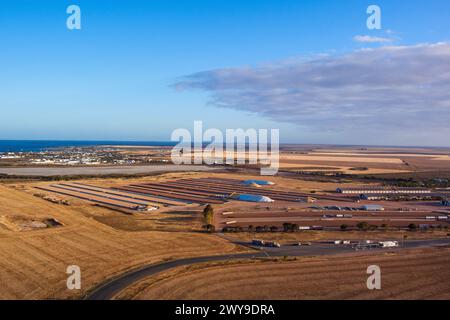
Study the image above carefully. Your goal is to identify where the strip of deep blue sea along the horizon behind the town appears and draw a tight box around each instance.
[0,140,176,152]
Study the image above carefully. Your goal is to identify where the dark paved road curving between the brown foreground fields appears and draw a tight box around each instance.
[85,239,450,300]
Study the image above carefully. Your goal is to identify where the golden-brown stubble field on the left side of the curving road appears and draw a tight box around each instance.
[0,185,236,299]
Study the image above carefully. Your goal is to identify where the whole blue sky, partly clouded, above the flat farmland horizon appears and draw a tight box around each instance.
[0,0,450,145]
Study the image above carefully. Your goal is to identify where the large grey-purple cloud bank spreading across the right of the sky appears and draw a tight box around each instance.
[175,42,450,139]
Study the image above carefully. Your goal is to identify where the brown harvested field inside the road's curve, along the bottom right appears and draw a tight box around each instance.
[126,248,450,300]
